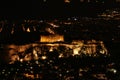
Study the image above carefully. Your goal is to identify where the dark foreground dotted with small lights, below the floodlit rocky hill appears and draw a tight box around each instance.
[0,56,120,80]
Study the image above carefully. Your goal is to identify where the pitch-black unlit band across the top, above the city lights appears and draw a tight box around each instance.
[0,0,118,17]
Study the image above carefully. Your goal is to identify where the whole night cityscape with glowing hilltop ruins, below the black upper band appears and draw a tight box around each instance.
[0,15,120,80]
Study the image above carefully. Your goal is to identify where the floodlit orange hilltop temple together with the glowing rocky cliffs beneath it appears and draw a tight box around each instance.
[6,39,109,62]
